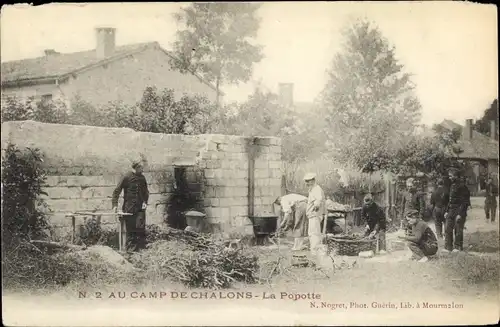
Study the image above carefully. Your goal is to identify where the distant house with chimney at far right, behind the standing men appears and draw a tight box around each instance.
[439,119,498,194]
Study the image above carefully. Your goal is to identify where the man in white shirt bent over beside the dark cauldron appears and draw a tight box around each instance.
[274,194,307,251]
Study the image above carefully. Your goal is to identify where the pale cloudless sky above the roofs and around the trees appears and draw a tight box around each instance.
[1,2,498,124]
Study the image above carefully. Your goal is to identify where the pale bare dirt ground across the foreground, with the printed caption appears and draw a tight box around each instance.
[3,202,499,326]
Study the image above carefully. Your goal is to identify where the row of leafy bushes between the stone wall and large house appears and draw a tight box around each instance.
[2,87,219,134]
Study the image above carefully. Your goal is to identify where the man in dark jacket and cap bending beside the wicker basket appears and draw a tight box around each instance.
[361,194,386,254]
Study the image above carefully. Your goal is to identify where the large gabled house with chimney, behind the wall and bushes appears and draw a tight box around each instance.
[1,28,216,109]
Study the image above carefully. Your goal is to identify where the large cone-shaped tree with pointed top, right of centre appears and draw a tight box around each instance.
[319,20,421,168]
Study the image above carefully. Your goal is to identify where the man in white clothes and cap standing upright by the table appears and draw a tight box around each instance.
[304,173,325,255]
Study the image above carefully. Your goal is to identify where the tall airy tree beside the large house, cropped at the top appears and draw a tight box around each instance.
[172,3,262,106]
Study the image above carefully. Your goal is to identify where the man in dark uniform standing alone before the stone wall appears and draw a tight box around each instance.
[111,161,149,251]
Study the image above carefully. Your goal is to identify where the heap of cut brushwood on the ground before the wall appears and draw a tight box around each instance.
[130,226,258,289]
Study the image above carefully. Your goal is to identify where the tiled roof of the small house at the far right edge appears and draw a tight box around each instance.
[440,119,498,160]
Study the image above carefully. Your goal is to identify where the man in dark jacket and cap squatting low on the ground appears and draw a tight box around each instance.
[398,210,438,262]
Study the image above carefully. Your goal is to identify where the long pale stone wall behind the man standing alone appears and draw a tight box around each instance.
[2,121,281,238]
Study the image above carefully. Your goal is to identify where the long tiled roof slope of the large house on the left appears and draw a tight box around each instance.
[2,42,154,84]
